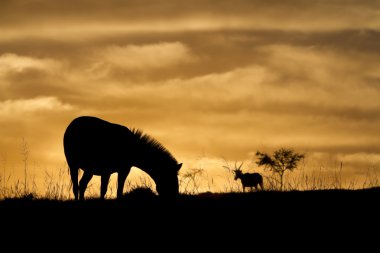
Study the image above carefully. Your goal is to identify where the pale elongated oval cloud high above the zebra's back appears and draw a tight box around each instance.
[99,42,194,70]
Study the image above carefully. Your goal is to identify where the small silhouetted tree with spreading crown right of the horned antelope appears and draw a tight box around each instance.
[256,148,305,190]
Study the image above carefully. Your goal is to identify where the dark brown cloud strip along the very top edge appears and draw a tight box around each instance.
[1,0,380,24]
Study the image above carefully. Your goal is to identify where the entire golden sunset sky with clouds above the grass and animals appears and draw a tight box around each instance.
[0,0,380,194]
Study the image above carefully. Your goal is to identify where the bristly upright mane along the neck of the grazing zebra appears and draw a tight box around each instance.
[131,128,178,164]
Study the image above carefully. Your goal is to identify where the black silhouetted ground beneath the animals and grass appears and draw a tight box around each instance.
[0,188,380,249]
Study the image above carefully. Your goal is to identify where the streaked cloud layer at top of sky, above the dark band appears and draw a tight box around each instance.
[0,0,380,41]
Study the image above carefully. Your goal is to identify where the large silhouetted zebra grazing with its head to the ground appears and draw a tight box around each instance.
[63,116,182,200]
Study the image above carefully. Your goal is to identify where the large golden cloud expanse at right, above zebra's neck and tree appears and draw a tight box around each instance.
[73,56,380,166]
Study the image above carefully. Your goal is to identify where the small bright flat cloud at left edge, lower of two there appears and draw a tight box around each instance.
[0,97,72,116]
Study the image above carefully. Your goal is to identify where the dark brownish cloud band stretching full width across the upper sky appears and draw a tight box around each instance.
[0,30,380,85]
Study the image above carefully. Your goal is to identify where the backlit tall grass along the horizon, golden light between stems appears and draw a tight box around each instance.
[0,164,380,200]
